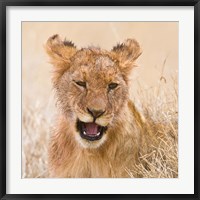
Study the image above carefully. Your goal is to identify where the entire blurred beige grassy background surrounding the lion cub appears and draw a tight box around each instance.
[22,22,178,178]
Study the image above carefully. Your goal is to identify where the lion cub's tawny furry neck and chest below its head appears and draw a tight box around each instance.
[49,102,141,177]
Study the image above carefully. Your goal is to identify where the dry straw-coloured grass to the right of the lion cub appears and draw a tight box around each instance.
[130,78,178,178]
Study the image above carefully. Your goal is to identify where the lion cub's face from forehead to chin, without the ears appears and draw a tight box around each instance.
[62,49,128,146]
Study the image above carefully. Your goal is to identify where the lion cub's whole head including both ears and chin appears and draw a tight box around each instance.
[46,35,141,148]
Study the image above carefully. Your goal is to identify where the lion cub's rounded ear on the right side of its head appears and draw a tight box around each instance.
[111,39,142,75]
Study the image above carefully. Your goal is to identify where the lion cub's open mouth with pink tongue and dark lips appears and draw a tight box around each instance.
[77,120,107,141]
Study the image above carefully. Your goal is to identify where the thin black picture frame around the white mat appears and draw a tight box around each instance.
[0,0,200,200]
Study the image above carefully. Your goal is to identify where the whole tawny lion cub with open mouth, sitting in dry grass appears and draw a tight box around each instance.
[46,35,148,178]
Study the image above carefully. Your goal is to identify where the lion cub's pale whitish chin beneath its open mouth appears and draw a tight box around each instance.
[75,132,107,149]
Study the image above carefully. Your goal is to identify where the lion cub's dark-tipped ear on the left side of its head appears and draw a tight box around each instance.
[45,35,77,81]
